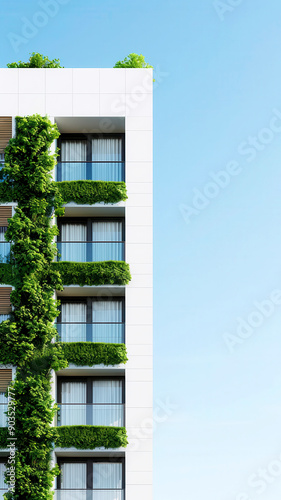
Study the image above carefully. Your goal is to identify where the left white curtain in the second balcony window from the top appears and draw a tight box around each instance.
[58,223,87,262]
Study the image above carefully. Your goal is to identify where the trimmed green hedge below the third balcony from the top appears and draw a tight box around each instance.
[59,342,128,366]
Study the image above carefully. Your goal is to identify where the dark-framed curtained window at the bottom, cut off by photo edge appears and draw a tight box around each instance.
[56,458,125,500]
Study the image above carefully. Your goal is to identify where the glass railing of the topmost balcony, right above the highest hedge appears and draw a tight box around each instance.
[56,161,125,182]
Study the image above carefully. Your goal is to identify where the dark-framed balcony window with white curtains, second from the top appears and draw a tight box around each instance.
[57,218,125,262]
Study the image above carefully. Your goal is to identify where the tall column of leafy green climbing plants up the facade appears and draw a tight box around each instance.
[0,115,67,500]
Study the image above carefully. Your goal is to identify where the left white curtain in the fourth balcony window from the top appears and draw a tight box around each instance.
[60,382,87,425]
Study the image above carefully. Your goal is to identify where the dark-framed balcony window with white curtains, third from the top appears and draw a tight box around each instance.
[56,297,125,344]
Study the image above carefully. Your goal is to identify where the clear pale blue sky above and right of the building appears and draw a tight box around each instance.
[0,0,281,500]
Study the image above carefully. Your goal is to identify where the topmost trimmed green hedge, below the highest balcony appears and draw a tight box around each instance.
[56,181,128,205]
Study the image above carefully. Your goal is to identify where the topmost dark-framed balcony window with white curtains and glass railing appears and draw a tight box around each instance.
[57,134,125,181]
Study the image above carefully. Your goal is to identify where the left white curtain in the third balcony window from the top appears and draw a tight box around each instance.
[58,302,87,342]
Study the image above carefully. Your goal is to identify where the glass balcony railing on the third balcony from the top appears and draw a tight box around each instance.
[56,323,125,344]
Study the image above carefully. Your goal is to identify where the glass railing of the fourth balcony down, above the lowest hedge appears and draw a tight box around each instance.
[57,403,125,427]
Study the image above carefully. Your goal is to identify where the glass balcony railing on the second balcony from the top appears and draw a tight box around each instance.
[57,241,125,262]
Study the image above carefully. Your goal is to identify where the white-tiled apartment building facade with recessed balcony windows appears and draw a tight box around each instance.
[0,68,153,500]
